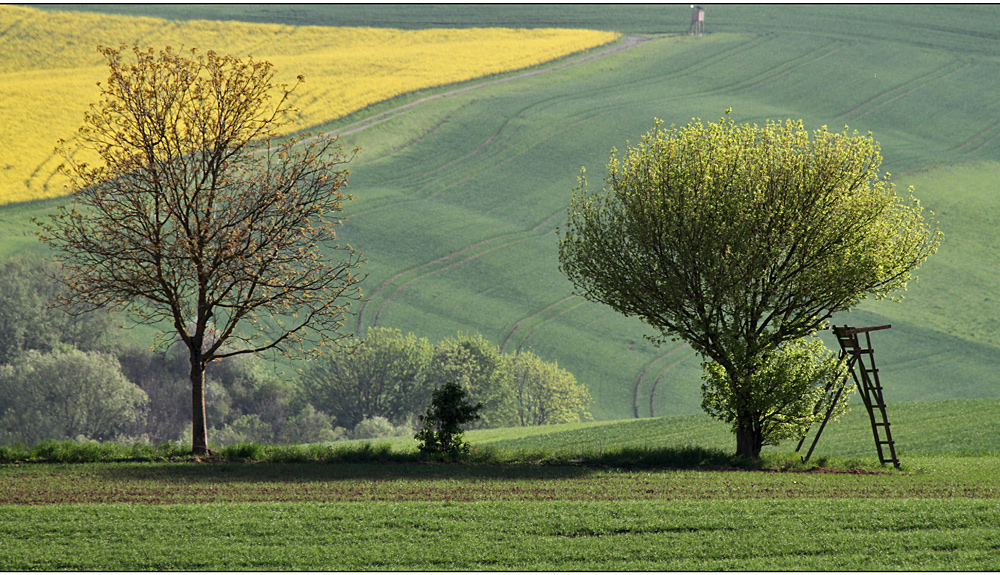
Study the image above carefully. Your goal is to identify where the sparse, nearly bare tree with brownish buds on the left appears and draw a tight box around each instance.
[40,46,370,453]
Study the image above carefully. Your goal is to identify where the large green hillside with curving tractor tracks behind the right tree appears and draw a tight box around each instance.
[11,6,1000,419]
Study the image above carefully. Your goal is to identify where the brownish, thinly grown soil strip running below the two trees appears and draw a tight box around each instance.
[0,463,1000,505]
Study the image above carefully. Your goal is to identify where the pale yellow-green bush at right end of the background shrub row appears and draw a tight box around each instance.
[510,351,591,425]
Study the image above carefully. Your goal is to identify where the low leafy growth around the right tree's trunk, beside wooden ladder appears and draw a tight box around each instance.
[701,338,852,445]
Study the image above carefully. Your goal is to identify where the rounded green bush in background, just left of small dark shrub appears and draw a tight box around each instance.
[302,327,434,429]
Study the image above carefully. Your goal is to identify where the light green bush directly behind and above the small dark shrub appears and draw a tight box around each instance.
[427,334,518,427]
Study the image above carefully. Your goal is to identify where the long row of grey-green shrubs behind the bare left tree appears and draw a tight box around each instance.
[0,254,591,445]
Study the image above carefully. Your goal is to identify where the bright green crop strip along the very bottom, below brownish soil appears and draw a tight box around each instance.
[0,498,1000,571]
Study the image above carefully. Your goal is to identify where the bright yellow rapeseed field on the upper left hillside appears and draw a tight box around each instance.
[0,6,617,204]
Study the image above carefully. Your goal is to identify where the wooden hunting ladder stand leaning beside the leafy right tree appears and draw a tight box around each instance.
[795,325,899,469]
